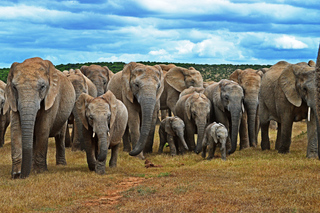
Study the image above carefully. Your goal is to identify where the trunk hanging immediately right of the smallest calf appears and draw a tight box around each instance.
[228,109,242,155]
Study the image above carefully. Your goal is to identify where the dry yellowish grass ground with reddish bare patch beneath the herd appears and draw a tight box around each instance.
[0,122,320,212]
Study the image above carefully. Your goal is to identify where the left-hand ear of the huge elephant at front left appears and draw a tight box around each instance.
[3,62,19,114]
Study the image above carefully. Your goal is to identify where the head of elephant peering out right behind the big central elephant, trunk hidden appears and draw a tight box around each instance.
[166,67,203,92]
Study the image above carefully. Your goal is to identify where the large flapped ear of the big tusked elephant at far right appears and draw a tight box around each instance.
[279,64,302,107]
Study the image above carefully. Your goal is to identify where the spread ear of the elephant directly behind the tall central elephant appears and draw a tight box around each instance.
[166,67,187,92]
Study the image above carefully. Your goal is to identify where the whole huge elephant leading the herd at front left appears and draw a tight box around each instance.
[4,57,76,178]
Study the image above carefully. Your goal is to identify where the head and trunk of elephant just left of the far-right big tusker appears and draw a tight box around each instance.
[229,69,263,146]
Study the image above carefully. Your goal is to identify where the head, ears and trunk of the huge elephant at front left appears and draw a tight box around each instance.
[4,58,60,178]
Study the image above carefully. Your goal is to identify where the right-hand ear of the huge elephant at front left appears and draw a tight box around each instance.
[44,60,60,110]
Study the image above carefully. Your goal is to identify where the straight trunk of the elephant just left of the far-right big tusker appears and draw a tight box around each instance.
[246,101,258,147]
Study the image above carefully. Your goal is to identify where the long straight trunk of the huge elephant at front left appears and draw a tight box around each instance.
[19,101,40,178]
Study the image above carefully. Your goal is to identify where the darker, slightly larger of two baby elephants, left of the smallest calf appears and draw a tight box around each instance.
[158,116,188,155]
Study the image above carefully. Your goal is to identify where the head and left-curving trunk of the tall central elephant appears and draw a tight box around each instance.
[122,62,164,156]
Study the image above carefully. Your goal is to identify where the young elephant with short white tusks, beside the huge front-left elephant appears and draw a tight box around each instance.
[76,91,128,174]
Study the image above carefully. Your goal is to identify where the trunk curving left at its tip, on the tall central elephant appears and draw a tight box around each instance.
[129,97,156,156]
